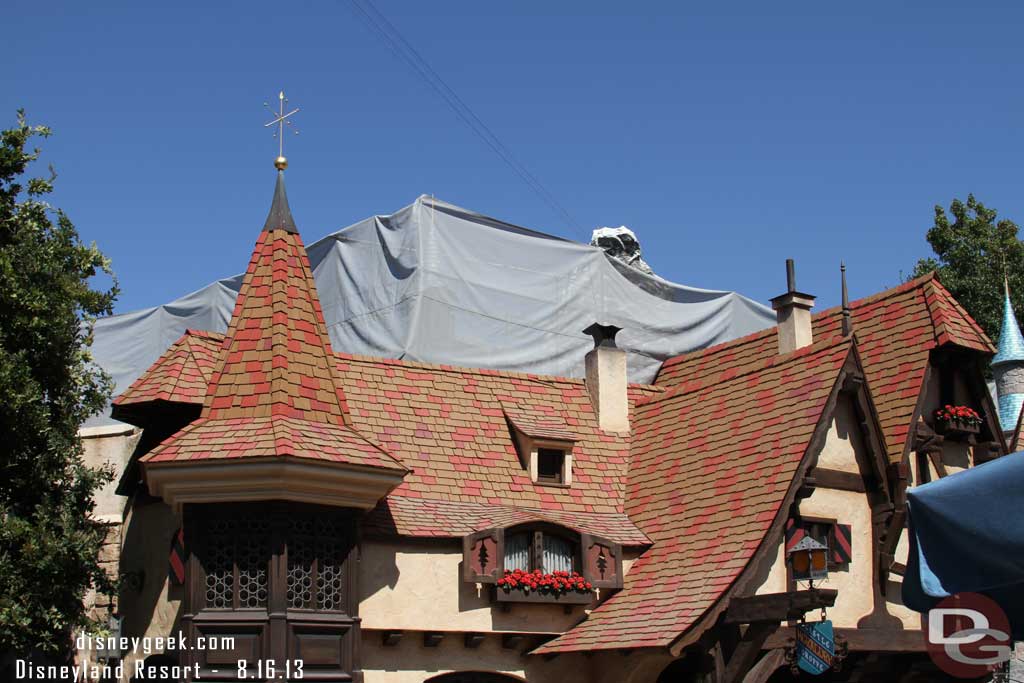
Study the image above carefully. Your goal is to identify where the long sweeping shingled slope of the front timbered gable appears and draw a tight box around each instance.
[536,338,852,653]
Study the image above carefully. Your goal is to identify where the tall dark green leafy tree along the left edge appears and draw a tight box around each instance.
[0,112,117,656]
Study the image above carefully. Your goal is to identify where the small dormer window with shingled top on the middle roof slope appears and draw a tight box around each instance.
[505,405,577,486]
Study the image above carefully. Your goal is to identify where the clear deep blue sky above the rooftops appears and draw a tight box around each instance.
[8,0,1024,311]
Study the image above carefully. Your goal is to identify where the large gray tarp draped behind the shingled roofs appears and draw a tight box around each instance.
[90,196,775,424]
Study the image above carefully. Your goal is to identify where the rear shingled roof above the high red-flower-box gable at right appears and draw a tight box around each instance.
[655,273,995,462]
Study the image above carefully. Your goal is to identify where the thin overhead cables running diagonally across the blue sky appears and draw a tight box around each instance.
[351,0,586,234]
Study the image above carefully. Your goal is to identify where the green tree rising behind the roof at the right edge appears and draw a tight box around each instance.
[913,195,1024,341]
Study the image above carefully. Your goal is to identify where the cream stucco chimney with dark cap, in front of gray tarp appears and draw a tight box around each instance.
[583,323,630,432]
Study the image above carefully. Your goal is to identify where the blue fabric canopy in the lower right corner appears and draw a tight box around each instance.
[903,452,1024,639]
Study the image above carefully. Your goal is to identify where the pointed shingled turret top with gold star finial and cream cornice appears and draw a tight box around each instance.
[139,114,408,510]
